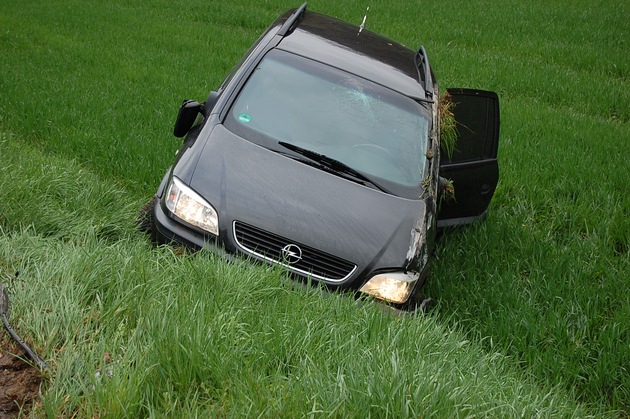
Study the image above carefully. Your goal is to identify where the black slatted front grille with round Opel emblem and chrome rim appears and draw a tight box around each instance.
[234,221,357,282]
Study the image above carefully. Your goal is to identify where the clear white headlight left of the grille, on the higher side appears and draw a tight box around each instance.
[165,177,219,236]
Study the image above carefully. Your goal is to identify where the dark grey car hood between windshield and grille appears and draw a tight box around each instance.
[184,125,426,284]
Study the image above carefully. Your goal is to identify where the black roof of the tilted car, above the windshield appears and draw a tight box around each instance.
[276,10,430,99]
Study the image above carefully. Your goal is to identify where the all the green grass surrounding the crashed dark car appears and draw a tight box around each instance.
[0,0,630,418]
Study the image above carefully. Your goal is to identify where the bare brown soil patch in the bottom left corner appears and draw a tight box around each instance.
[0,340,42,419]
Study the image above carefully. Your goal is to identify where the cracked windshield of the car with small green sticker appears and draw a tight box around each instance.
[226,51,430,197]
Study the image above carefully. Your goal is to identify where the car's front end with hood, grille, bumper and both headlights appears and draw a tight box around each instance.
[155,120,440,303]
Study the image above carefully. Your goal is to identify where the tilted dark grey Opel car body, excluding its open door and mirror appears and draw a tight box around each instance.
[146,4,439,304]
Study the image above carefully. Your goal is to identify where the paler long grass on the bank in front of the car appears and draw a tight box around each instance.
[0,135,603,417]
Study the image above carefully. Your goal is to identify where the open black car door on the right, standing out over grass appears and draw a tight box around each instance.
[438,89,499,227]
